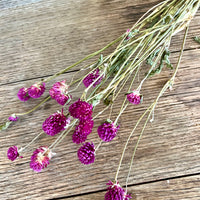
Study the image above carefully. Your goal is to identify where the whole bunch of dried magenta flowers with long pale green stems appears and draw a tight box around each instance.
[0,0,200,200]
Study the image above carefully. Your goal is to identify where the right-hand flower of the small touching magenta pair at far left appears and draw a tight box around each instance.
[28,83,45,99]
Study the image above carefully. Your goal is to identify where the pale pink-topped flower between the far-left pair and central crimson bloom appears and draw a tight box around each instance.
[49,80,71,106]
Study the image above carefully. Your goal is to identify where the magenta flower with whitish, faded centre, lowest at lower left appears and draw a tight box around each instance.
[30,146,53,172]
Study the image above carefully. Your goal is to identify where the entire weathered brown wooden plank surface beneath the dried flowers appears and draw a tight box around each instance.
[0,0,200,200]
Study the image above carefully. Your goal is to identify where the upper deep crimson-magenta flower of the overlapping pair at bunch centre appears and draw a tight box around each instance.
[69,99,93,120]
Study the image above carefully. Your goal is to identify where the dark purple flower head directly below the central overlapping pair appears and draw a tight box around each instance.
[77,142,95,165]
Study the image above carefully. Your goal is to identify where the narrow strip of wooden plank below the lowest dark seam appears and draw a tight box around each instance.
[66,175,200,200]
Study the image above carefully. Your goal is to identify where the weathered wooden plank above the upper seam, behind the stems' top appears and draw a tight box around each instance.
[0,0,200,84]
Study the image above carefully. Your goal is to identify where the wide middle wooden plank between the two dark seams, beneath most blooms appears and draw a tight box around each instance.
[0,50,200,200]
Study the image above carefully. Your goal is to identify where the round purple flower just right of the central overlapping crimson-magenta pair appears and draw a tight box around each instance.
[97,121,120,142]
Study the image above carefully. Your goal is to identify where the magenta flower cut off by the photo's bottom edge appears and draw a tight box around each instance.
[105,181,132,200]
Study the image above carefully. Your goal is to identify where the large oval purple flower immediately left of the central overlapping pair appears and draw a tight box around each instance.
[42,112,67,136]
